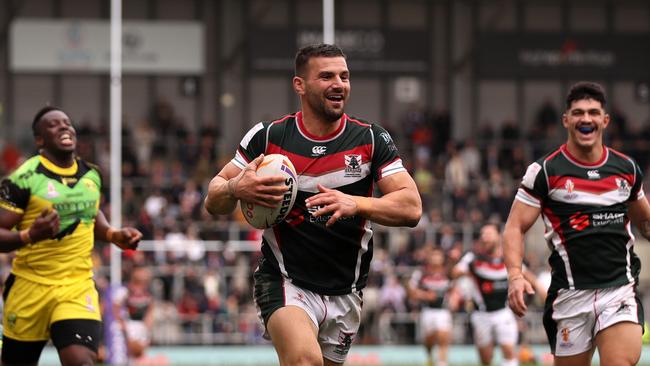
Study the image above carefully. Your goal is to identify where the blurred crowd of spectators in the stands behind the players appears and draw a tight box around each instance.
[0,100,650,352]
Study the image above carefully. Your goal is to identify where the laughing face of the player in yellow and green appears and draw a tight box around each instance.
[35,110,77,156]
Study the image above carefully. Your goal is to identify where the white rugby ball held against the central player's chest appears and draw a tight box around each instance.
[241,154,298,229]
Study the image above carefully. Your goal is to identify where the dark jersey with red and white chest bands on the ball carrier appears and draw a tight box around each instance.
[232,112,405,295]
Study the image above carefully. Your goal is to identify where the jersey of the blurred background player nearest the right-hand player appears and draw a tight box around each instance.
[456,252,508,311]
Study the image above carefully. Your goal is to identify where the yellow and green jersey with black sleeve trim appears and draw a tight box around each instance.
[0,155,102,285]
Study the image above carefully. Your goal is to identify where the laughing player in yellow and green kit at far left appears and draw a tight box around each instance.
[0,106,142,366]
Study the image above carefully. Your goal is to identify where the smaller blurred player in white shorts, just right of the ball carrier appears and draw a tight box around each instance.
[408,247,454,366]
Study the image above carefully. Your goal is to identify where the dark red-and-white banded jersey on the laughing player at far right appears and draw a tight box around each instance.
[516,145,645,289]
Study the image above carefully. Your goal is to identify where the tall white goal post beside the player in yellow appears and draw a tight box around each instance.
[110,0,122,286]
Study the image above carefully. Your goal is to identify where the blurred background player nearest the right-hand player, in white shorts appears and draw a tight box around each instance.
[452,224,544,366]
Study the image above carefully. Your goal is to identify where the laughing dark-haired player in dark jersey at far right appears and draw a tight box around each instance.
[504,82,650,366]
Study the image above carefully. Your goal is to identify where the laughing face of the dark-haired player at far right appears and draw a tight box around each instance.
[562,99,609,151]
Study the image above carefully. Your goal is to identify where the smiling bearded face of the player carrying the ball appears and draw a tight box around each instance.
[293,57,350,123]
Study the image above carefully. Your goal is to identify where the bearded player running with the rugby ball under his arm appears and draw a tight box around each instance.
[205,44,422,365]
